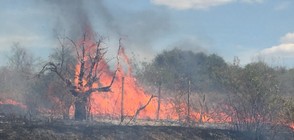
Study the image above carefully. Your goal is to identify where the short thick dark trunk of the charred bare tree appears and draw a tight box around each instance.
[74,97,87,121]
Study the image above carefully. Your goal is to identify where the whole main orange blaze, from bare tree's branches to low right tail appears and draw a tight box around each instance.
[71,32,225,122]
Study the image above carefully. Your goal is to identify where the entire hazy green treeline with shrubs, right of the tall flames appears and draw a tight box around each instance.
[136,48,294,136]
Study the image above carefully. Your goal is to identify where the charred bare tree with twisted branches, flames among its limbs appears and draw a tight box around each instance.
[39,33,121,120]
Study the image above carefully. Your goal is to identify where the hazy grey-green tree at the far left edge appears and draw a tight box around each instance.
[0,43,37,116]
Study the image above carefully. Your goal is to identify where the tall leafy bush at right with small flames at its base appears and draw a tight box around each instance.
[218,62,282,139]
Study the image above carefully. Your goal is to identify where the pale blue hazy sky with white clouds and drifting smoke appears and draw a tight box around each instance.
[0,0,294,67]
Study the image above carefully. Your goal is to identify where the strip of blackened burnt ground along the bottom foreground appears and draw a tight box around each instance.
[0,116,272,140]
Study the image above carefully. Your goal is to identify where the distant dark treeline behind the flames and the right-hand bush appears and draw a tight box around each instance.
[136,48,294,95]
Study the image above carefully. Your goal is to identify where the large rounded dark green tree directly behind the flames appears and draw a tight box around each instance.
[139,48,226,94]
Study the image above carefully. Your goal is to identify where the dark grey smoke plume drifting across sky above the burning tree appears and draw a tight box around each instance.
[38,0,171,58]
